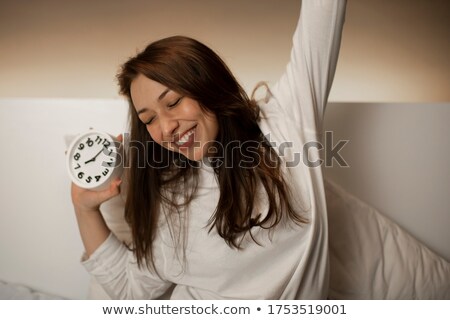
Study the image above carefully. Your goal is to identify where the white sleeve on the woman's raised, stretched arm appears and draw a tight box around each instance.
[271,0,346,133]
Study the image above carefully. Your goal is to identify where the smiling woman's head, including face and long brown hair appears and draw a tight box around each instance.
[118,36,306,272]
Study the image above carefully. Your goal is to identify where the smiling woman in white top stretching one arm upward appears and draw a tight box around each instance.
[72,0,345,299]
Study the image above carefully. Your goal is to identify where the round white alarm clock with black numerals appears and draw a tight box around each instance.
[67,131,124,190]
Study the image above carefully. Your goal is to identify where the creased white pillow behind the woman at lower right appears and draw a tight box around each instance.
[325,180,450,299]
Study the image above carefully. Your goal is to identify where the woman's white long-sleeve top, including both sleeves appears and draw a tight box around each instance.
[82,0,346,299]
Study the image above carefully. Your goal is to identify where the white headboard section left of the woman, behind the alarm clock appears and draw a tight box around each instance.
[0,99,127,299]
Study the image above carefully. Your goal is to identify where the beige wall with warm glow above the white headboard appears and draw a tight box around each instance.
[0,0,450,102]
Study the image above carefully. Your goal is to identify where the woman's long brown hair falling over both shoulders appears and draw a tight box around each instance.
[117,36,306,266]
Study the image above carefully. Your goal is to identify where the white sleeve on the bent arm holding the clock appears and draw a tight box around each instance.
[82,233,172,299]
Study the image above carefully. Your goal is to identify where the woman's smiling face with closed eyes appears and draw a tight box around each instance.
[131,74,219,161]
